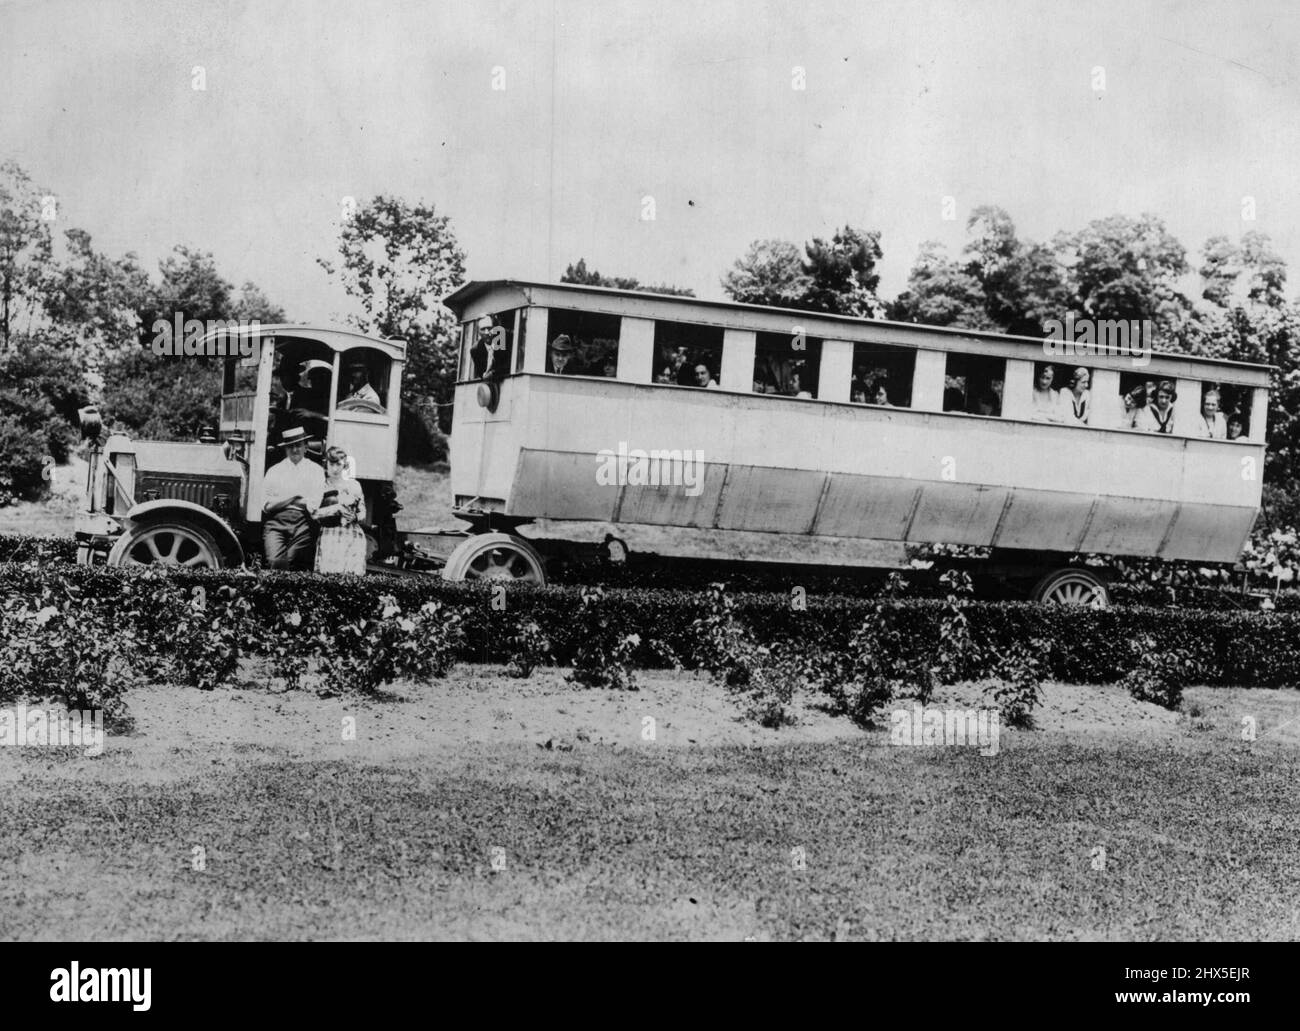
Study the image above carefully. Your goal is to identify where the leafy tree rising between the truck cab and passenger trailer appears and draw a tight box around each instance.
[319,195,465,460]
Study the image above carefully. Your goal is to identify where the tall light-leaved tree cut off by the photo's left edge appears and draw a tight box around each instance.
[0,161,53,350]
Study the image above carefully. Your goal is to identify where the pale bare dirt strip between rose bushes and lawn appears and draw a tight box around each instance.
[0,666,1300,784]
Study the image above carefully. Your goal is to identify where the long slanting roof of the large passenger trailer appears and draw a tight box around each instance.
[442,280,1273,373]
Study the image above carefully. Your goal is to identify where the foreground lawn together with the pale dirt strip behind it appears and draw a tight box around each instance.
[0,667,1300,940]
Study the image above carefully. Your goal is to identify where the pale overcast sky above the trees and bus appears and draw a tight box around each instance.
[0,0,1300,321]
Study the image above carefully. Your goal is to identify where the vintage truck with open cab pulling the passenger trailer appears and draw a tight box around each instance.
[75,326,406,568]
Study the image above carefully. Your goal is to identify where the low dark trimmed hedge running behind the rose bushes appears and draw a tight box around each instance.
[0,564,1300,686]
